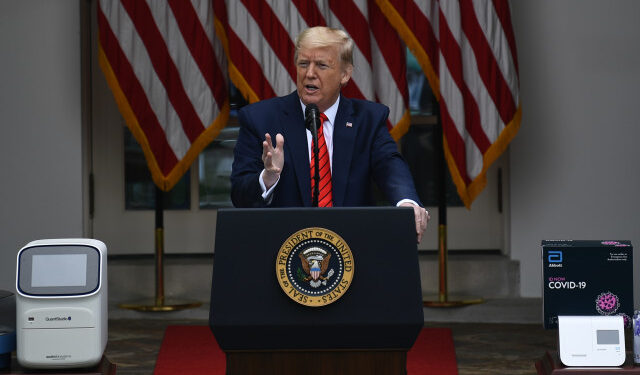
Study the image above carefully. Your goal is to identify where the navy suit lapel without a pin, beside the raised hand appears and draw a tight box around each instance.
[281,91,311,207]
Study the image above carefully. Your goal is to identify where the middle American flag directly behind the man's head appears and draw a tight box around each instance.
[213,0,410,139]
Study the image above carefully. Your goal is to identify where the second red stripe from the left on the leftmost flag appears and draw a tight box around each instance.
[121,0,205,142]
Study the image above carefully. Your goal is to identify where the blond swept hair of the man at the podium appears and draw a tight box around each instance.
[293,26,353,67]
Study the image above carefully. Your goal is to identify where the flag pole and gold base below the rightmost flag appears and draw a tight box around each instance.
[423,105,484,307]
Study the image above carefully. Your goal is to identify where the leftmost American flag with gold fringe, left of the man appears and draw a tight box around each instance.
[98,0,229,191]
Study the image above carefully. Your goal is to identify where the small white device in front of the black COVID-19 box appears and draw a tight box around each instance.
[558,315,626,367]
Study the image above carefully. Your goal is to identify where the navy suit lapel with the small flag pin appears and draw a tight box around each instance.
[331,96,358,206]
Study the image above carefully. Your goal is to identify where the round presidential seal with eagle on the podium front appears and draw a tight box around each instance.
[276,227,354,307]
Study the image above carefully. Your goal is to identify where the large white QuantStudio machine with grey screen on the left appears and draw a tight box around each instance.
[16,239,107,369]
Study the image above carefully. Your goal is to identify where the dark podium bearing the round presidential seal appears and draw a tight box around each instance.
[209,207,424,375]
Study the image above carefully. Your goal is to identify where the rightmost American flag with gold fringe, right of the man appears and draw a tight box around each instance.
[376,0,522,207]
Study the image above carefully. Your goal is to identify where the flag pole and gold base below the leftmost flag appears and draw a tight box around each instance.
[119,186,202,311]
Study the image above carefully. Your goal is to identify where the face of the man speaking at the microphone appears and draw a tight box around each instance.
[296,47,352,112]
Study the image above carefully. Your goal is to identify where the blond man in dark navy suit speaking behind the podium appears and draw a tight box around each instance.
[231,27,429,241]
